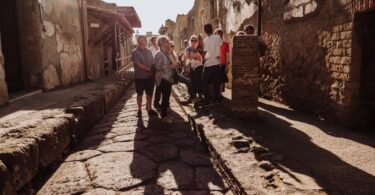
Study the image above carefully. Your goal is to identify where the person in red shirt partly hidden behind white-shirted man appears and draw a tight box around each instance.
[215,29,230,95]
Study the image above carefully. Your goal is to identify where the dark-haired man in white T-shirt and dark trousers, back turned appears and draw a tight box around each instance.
[202,24,223,105]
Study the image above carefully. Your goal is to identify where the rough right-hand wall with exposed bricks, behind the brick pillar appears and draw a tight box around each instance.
[261,0,358,124]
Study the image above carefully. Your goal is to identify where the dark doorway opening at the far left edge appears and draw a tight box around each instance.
[0,0,23,94]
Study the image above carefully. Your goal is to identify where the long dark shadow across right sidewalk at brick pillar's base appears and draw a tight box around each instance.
[203,103,375,194]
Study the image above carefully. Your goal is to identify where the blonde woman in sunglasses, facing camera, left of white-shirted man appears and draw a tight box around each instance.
[185,35,203,97]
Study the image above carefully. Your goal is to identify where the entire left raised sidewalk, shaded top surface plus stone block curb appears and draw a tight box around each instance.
[0,76,131,195]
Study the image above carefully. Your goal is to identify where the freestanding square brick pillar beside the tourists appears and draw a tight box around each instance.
[231,36,260,119]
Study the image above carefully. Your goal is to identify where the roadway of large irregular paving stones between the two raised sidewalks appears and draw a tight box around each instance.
[38,87,231,195]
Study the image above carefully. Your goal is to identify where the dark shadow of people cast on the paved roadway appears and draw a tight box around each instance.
[131,104,228,195]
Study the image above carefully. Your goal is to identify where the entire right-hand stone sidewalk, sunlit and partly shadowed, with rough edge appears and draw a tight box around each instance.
[173,86,375,194]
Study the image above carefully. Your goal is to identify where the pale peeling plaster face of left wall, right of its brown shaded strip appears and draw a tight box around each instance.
[41,0,85,89]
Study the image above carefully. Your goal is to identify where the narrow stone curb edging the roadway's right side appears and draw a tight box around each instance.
[172,87,247,195]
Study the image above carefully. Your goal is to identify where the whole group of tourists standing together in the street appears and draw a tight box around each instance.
[132,24,264,123]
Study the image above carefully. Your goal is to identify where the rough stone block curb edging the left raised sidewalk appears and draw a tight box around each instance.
[0,80,132,195]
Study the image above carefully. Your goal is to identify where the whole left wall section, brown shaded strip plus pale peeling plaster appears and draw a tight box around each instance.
[17,0,85,90]
